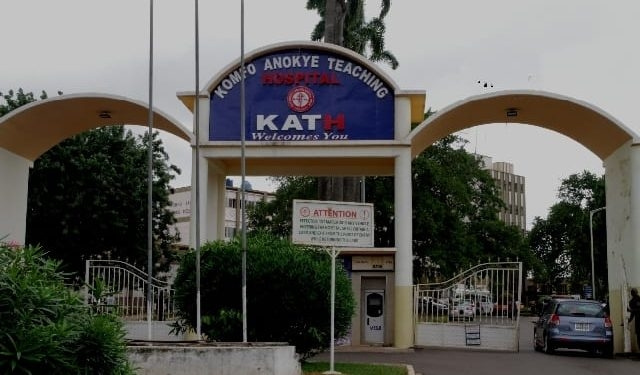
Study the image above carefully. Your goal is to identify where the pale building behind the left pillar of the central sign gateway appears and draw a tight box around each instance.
[169,184,275,247]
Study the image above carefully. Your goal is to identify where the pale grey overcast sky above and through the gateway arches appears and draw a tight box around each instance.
[0,0,640,229]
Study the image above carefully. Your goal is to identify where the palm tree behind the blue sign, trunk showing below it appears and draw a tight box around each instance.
[307,0,398,202]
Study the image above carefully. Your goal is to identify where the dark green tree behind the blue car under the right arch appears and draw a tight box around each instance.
[529,171,608,296]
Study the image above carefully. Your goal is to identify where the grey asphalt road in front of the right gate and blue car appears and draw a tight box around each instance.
[314,317,640,375]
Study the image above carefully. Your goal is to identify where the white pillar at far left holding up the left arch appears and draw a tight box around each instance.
[0,148,32,245]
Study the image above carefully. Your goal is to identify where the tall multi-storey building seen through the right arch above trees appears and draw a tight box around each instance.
[478,155,527,232]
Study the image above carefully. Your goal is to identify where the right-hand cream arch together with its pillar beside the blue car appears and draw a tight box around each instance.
[408,90,640,351]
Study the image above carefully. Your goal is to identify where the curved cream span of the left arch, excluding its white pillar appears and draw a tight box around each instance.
[0,93,193,161]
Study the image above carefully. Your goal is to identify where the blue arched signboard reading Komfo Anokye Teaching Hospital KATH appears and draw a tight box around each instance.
[209,48,394,142]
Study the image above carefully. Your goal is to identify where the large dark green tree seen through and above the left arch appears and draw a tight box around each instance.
[0,89,180,273]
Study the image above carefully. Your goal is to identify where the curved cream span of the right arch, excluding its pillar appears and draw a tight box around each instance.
[408,90,638,160]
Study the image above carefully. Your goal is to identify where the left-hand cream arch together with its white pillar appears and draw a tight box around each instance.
[0,93,193,244]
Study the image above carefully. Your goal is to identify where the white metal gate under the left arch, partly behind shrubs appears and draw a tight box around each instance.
[85,260,175,321]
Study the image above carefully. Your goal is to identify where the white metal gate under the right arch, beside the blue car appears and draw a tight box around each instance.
[414,262,522,350]
